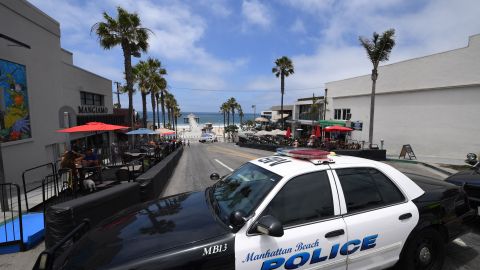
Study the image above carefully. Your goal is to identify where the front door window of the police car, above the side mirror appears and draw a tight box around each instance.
[263,172,334,226]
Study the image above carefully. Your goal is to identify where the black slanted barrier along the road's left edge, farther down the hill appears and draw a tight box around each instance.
[135,146,183,201]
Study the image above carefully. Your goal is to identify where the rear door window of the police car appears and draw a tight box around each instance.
[336,168,404,213]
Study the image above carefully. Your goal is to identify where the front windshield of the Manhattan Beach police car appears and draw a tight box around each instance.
[212,163,282,224]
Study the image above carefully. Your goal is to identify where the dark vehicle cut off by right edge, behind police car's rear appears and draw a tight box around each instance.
[445,153,480,212]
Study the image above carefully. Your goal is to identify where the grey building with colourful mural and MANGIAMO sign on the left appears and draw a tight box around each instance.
[0,0,115,183]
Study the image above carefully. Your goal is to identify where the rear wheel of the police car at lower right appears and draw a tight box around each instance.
[397,228,445,270]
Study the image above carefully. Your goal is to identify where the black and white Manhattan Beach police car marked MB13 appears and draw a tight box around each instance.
[43,149,475,270]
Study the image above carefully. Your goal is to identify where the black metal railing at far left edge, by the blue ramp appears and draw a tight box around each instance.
[0,183,25,251]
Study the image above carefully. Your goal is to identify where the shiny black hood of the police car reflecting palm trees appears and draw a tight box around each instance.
[60,192,231,269]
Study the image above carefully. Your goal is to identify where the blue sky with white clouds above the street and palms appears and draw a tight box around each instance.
[29,0,480,113]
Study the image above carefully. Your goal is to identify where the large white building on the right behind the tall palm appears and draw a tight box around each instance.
[326,35,480,164]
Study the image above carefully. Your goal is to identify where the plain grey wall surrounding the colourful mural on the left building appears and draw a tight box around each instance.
[0,0,112,183]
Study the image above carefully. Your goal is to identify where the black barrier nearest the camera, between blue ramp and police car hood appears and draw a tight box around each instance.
[45,183,140,250]
